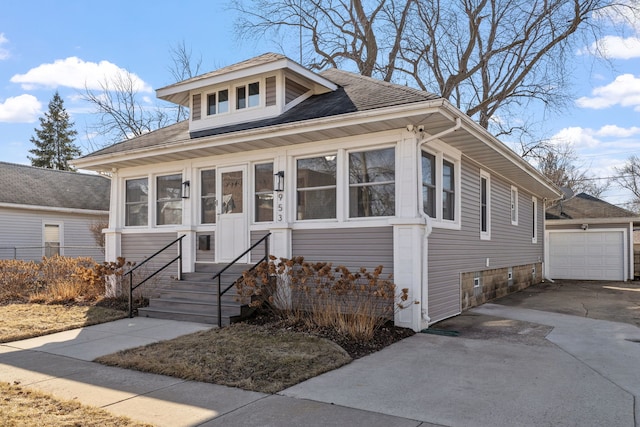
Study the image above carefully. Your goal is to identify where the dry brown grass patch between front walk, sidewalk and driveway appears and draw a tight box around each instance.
[96,323,351,393]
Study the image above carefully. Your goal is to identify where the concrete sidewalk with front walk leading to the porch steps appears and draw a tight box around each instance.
[0,317,429,427]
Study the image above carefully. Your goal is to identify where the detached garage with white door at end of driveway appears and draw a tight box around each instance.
[545,193,640,280]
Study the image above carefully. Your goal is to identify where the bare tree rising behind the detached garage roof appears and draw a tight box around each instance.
[538,143,610,197]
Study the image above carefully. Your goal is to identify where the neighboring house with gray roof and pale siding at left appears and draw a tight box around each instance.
[0,162,111,262]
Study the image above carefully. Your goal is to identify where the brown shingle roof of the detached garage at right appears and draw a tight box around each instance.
[545,193,637,219]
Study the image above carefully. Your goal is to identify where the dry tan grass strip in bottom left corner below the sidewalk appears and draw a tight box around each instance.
[0,383,150,427]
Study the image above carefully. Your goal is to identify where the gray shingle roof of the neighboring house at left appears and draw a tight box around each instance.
[0,162,111,211]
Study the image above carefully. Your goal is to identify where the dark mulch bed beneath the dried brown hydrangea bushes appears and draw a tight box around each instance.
[245,311,415,359]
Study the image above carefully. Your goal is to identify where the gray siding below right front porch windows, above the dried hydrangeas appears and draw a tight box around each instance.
[291,227,393,277]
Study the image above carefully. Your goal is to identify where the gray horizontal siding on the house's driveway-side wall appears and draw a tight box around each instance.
[428,158,544,322]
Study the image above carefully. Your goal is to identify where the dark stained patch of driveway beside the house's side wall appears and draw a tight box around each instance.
[425,312,553,346]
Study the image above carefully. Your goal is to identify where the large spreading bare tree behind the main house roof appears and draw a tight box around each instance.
[232,0,638,135]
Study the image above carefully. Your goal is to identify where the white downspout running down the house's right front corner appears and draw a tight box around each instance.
[416,117,462,326]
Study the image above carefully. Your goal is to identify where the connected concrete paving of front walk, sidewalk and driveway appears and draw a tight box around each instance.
[0,304,640,427]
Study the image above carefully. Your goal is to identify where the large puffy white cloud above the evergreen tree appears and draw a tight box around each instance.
[11,56,152,92]
